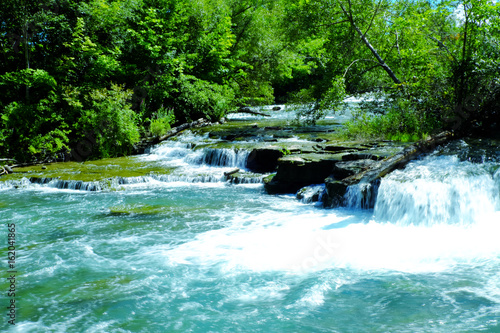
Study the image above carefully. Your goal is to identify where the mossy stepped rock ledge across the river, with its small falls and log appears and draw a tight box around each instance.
[0,106,498,208]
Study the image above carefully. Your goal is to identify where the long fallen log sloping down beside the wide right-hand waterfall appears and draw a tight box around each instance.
[325,132,454,207]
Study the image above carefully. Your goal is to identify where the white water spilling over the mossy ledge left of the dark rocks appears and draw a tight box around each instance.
[0,134,263,191]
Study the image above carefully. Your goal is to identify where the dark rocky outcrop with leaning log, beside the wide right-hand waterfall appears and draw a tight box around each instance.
[264,132,453,208]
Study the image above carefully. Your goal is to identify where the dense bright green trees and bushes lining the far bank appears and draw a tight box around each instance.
[0,0,500,161]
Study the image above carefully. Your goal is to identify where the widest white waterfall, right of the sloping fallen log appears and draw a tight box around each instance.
[374,156,500,226]
